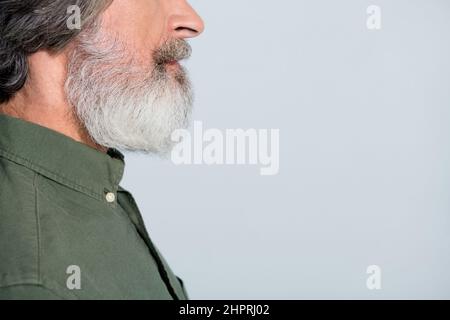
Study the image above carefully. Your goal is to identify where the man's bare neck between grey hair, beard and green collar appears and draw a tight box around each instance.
[0,53,107,152]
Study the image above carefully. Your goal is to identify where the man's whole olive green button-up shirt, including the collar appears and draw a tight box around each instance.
[0,115,188,300]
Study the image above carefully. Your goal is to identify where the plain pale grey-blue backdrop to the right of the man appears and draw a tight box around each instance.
[123,0,450,299]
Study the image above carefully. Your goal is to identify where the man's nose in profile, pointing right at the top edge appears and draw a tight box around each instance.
[169,0,205,39]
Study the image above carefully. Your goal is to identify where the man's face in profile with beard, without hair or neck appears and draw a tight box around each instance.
[65,0,204,154]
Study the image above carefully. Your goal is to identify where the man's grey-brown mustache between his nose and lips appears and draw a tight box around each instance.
[153,39,192,65]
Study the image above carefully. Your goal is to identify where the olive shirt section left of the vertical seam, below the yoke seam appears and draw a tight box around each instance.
[0,157,38,287]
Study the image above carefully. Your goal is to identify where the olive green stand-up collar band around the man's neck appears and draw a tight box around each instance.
[0,115,125,201]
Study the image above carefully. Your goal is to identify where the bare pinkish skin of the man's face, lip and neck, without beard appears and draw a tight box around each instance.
[0,0,204,151]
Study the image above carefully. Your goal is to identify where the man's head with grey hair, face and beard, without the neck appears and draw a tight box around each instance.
[0,0,203,152]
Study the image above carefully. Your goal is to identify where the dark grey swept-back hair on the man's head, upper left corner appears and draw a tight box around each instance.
[0,0,112,104]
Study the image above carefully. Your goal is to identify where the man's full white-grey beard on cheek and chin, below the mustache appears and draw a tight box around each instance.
[65,26,193,155]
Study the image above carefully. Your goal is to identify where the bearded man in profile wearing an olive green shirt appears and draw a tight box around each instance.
[0,0,203,300]
